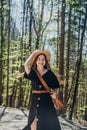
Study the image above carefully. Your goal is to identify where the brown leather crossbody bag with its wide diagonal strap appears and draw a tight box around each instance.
[35,70,64,110]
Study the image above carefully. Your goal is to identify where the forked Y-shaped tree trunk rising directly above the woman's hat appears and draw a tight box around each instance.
[33,0,53,49]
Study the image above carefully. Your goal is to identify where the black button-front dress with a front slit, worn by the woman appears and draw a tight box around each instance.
[23,69,61,130]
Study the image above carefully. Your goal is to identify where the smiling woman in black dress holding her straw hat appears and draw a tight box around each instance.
[17,50,61,130]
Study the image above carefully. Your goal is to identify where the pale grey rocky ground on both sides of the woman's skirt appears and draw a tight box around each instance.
[0,106,87,130]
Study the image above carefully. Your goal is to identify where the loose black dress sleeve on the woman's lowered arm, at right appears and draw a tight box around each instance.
[51,72,60,89]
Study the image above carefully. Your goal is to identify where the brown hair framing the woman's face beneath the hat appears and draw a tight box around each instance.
[31,53,51,70]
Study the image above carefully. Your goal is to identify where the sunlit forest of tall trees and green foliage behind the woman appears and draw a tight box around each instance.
[0,0,87,121]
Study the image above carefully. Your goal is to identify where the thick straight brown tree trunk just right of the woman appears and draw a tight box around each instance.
[59,0,66,115]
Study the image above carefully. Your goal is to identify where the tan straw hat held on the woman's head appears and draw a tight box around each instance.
[27,50,51,66]
